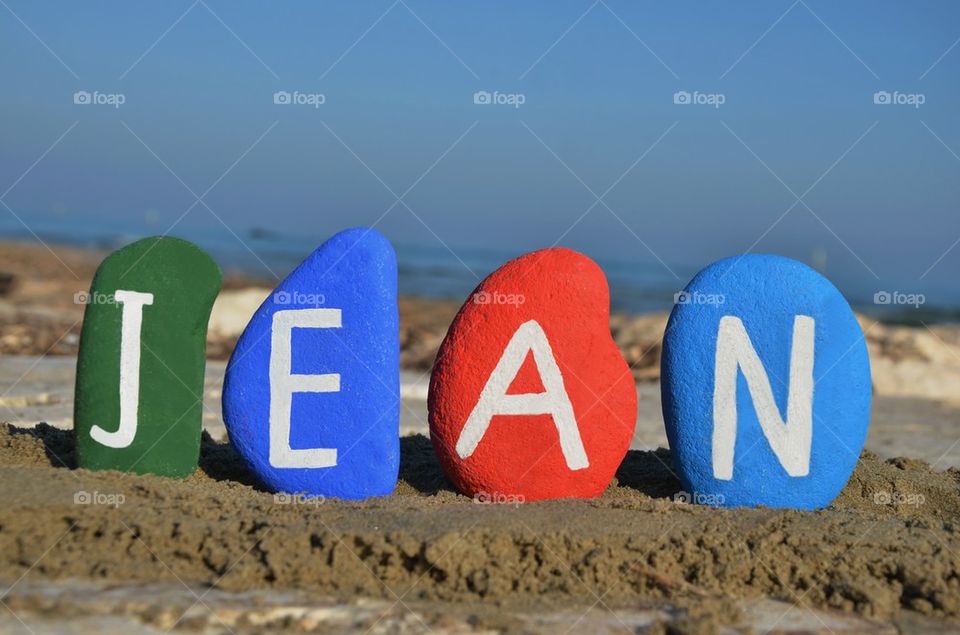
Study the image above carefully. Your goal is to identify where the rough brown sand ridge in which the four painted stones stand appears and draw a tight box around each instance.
[0,424,960,632]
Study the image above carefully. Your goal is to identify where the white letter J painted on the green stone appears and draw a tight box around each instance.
[90,289,153,449]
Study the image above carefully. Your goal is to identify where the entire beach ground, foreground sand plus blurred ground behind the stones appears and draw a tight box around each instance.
[0,241,960,634]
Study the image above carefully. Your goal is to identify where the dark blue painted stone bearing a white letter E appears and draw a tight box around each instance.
[223,227,400,499]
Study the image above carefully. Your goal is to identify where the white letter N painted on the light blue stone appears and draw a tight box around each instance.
[713,315,814,481]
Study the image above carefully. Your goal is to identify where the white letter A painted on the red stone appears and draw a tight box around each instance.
[457,320,590,470]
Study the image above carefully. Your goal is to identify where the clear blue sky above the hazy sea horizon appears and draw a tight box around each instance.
[0,0,960,304]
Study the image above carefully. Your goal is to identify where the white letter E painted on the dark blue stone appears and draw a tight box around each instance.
[270,309,342,467]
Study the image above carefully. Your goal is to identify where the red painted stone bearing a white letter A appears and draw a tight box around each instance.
[428,248,637,501]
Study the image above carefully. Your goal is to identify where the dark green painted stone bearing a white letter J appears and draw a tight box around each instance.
[74,237,222,477]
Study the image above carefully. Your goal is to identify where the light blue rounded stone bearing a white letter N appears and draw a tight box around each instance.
[661,254,871,509]
